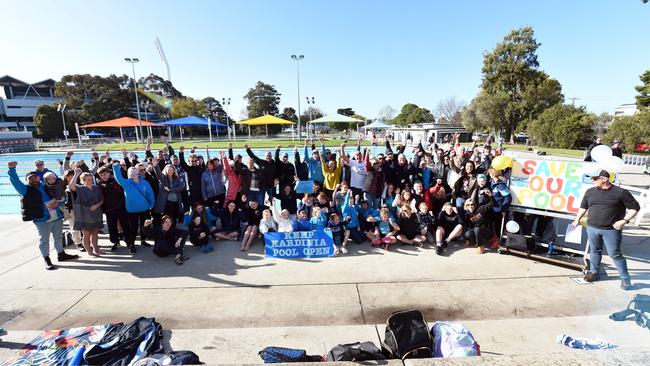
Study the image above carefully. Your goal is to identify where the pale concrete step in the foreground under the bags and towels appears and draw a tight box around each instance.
[0,316,650,366]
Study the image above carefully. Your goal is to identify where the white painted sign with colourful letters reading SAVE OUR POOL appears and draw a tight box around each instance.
[510,159,596,213]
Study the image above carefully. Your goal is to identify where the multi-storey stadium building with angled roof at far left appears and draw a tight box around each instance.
[0,75,58,130]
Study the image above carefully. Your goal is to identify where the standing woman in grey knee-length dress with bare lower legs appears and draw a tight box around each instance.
[70,168,104,257]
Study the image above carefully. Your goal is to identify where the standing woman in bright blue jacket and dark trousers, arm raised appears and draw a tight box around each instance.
[113,163,156,254]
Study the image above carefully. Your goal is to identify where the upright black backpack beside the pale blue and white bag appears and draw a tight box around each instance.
[381,310,433,360]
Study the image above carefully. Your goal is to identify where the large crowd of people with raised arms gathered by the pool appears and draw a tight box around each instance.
[9,134,511,269]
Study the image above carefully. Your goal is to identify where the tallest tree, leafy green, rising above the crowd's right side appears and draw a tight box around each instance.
[481,27,564,142]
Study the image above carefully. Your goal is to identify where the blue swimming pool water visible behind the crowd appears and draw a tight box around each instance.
[0,146,394,214]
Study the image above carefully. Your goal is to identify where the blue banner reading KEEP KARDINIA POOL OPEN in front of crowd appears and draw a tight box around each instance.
[264,230,334,258]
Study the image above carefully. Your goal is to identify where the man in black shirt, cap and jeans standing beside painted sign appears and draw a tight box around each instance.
[571,170,640,290]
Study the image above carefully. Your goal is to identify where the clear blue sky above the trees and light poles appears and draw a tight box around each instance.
[5,0,650,119]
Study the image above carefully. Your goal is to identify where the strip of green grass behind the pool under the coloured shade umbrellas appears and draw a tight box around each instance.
[95,138,370,151]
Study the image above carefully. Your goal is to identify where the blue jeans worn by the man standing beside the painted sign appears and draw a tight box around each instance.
[587,225,630,279]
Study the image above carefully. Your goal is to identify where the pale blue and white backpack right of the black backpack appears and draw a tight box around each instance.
[431,322,481,357]
